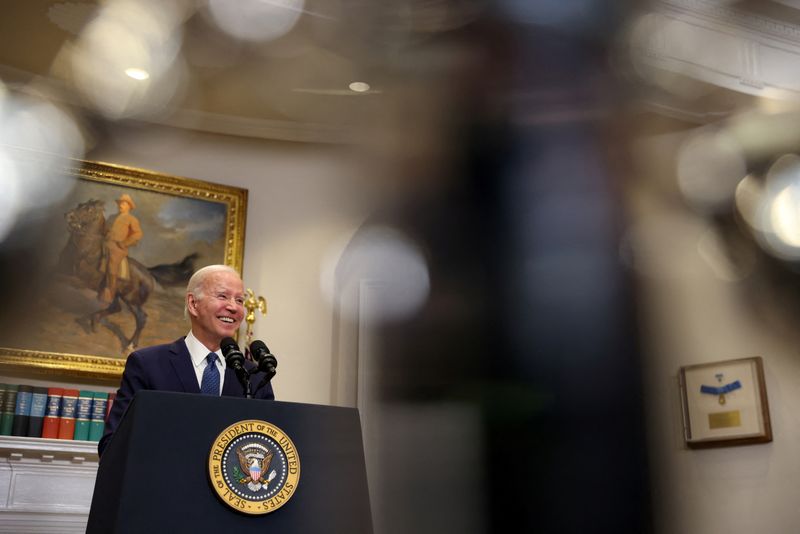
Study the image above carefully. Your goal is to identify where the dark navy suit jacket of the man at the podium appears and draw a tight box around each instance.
[97,338,275,455]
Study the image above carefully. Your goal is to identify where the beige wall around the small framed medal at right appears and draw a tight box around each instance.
[631,133,800,534]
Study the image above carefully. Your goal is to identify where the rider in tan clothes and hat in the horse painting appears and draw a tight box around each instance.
[98,193,143,302]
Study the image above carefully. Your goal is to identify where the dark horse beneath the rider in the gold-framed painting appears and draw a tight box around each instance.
[59,200,197,350]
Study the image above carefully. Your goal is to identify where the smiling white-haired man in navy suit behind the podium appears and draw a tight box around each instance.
[97,265,275,455]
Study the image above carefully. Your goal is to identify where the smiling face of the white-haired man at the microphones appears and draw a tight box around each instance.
[186,271,245,350]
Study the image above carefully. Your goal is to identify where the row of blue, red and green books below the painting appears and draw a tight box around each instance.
[0,384,116,441]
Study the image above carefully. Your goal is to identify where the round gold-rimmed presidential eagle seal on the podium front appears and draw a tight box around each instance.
[208,419,300,514]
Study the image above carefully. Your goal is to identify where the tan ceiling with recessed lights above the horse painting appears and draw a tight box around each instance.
[0,0,424,140]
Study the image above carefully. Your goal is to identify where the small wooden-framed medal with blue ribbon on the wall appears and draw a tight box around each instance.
[680,356,772,449]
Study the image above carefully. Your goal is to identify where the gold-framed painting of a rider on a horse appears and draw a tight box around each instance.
[0,161,247,382]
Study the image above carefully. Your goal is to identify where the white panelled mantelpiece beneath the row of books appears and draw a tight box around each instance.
[0,436,98,534]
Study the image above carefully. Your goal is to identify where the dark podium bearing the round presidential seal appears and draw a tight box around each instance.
[86,391,372,534]
